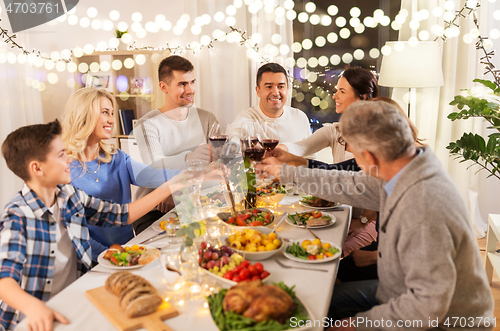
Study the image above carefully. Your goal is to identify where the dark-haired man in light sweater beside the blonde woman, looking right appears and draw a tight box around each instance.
[134,55,217,232]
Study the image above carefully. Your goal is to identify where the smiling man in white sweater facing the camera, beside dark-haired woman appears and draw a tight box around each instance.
[229,63,311,143]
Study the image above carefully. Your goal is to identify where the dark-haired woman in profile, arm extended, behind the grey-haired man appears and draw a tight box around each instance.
[278,68,378,163]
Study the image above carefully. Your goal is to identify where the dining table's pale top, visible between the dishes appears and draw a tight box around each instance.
[16,194,352,331]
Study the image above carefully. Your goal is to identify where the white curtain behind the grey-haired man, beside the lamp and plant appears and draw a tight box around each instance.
[392,0,500,237]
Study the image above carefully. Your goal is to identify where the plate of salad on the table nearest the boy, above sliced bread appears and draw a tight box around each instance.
[97,245,156,270]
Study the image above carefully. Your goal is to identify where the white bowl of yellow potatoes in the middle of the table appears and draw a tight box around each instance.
[225,227,283,261]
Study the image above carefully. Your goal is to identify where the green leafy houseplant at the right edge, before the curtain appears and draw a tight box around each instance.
[446,79,500,179]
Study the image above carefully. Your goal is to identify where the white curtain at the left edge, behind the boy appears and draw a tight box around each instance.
[0,15,43,209]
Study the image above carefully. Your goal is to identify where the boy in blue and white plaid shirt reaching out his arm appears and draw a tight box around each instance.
[0,120,182,330]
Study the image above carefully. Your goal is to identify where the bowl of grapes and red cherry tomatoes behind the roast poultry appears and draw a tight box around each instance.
[198,242,271,285]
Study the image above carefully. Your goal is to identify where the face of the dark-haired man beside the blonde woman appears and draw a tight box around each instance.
[160,70,196,109]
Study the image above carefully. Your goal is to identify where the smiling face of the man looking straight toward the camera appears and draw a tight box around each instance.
[255,72,288,118]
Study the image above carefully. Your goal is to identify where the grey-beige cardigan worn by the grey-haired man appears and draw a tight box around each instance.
[280,147,494,330]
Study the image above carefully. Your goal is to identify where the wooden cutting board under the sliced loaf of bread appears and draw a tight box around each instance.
[85,286,179,331]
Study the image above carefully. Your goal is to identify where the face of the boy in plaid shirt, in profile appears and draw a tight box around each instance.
[37,136,71,187]
